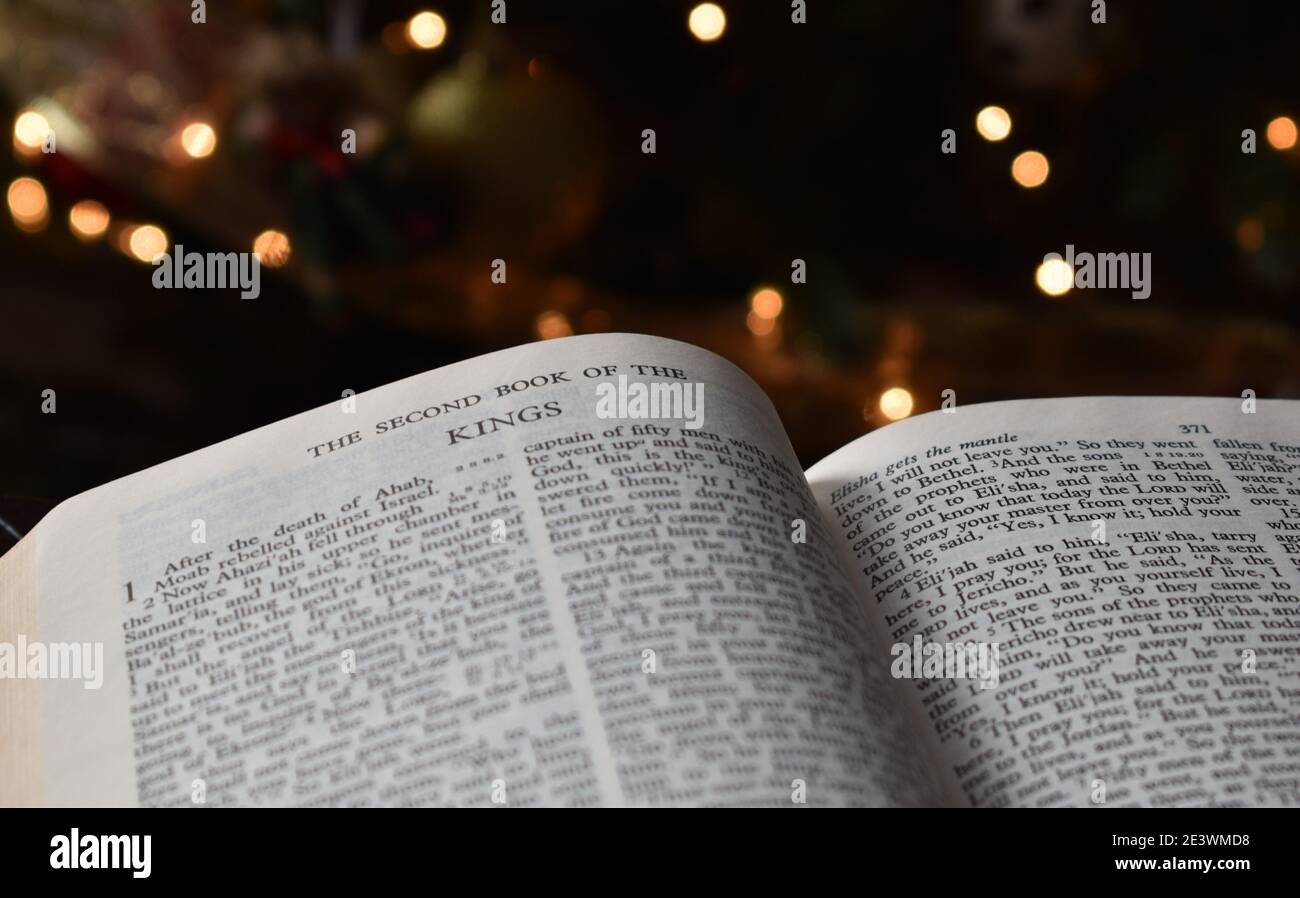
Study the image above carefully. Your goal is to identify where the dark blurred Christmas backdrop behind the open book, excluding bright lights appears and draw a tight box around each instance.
[0,0,1300,540]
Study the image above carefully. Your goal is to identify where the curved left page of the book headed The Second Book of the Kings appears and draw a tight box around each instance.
[0,334,939,806]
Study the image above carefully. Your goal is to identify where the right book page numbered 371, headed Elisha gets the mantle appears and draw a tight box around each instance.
[807,398,1300,806]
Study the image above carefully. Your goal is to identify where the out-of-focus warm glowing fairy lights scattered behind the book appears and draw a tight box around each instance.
[7,3,1297,431]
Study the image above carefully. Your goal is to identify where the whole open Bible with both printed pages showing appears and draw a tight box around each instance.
[0,334,1300,806]
